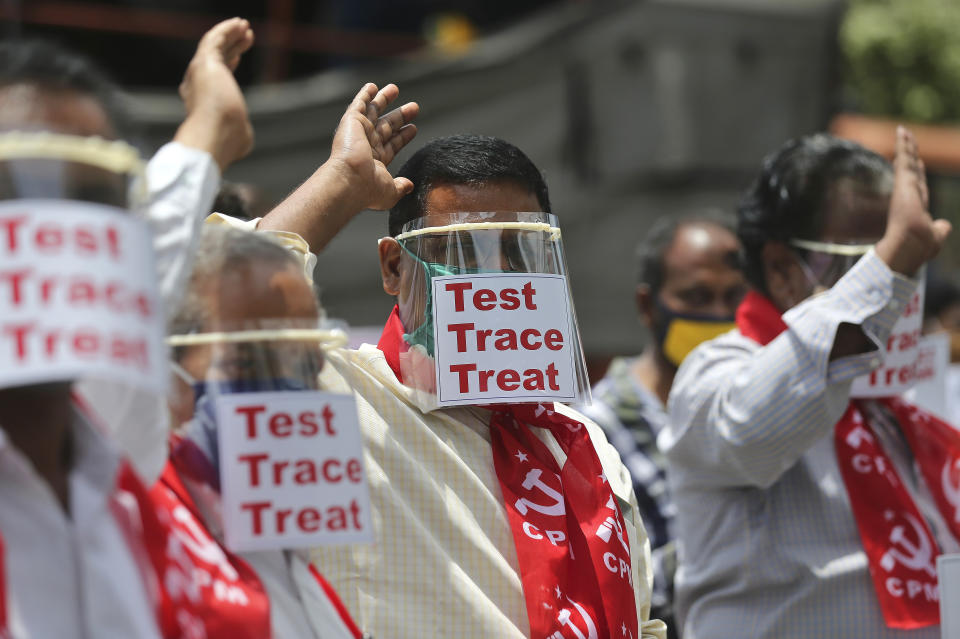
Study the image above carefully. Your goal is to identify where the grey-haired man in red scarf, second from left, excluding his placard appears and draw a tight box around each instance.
[152,226,361,639]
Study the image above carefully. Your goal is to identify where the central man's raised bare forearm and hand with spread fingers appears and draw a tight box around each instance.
[257,84,420,252]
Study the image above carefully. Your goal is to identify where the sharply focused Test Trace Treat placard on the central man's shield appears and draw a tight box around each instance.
[432,273,576,406]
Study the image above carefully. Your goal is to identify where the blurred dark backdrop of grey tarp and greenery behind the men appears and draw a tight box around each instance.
[7,0,960,379]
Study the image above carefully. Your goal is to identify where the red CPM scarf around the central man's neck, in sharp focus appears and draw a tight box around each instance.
[377,307,638,639]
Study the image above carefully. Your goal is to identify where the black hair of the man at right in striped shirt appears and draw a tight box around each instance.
[737,133,892,293]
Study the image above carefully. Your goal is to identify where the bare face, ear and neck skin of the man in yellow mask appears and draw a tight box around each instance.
[633,222,747,404]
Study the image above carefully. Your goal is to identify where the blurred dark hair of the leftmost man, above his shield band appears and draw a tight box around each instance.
[0,40,130,138]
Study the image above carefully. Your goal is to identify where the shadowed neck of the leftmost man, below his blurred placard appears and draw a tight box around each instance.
[0,384,73,510]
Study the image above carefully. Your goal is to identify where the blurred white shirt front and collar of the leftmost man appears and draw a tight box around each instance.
[0,416,160,639]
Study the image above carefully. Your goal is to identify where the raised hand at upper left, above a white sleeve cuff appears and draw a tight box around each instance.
[174,18,253,171]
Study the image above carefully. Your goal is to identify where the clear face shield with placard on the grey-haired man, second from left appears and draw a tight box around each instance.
[167,318,371,551]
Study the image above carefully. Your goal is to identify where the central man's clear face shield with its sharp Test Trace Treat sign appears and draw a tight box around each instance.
[395,212,590,409]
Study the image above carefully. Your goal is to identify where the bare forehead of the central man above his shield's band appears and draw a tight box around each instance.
[424,182,540,226]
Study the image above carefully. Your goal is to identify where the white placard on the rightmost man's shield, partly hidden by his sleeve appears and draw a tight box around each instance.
[850,280,924,398]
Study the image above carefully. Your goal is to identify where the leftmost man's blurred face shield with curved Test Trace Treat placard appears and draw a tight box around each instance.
[0,132,166,401]
